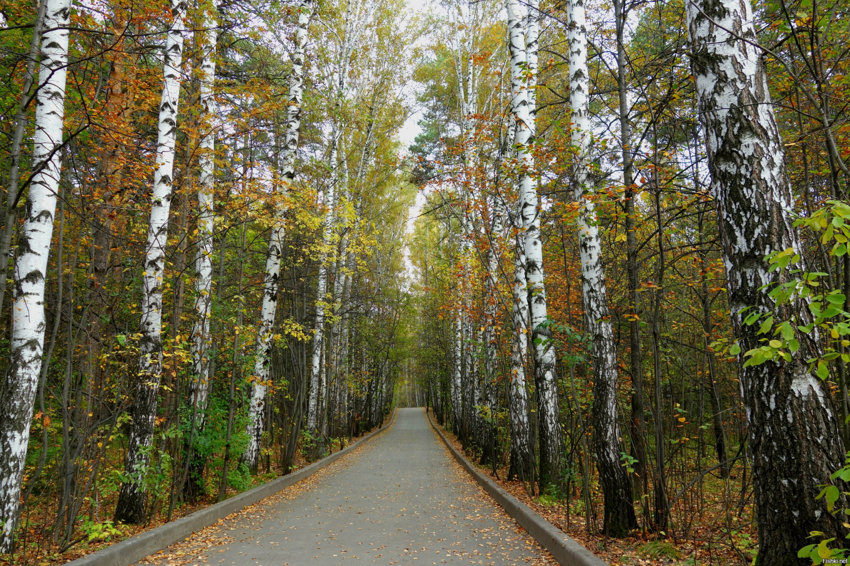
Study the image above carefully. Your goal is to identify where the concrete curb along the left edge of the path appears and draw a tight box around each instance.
[67,411,396,566]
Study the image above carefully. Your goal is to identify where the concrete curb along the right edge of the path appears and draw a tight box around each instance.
[428,413,607,566]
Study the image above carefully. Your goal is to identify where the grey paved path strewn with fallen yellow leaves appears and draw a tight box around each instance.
[143,409,554,566]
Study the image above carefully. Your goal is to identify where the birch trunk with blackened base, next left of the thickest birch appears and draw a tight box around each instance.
[567,0,637,537]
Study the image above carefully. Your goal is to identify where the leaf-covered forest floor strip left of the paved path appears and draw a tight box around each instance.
[0,431,371,566]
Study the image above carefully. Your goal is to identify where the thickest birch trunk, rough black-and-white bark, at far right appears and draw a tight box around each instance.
[687,0,846,566]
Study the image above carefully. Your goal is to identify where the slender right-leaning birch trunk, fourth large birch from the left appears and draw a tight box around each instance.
[242,0,313,471]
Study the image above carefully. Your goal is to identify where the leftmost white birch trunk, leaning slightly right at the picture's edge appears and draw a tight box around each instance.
[0,0,71,553]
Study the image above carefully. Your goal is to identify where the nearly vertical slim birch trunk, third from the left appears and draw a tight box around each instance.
[190,0,218,444]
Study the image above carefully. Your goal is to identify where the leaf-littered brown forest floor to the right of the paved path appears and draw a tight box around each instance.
[435,421,758,566]
